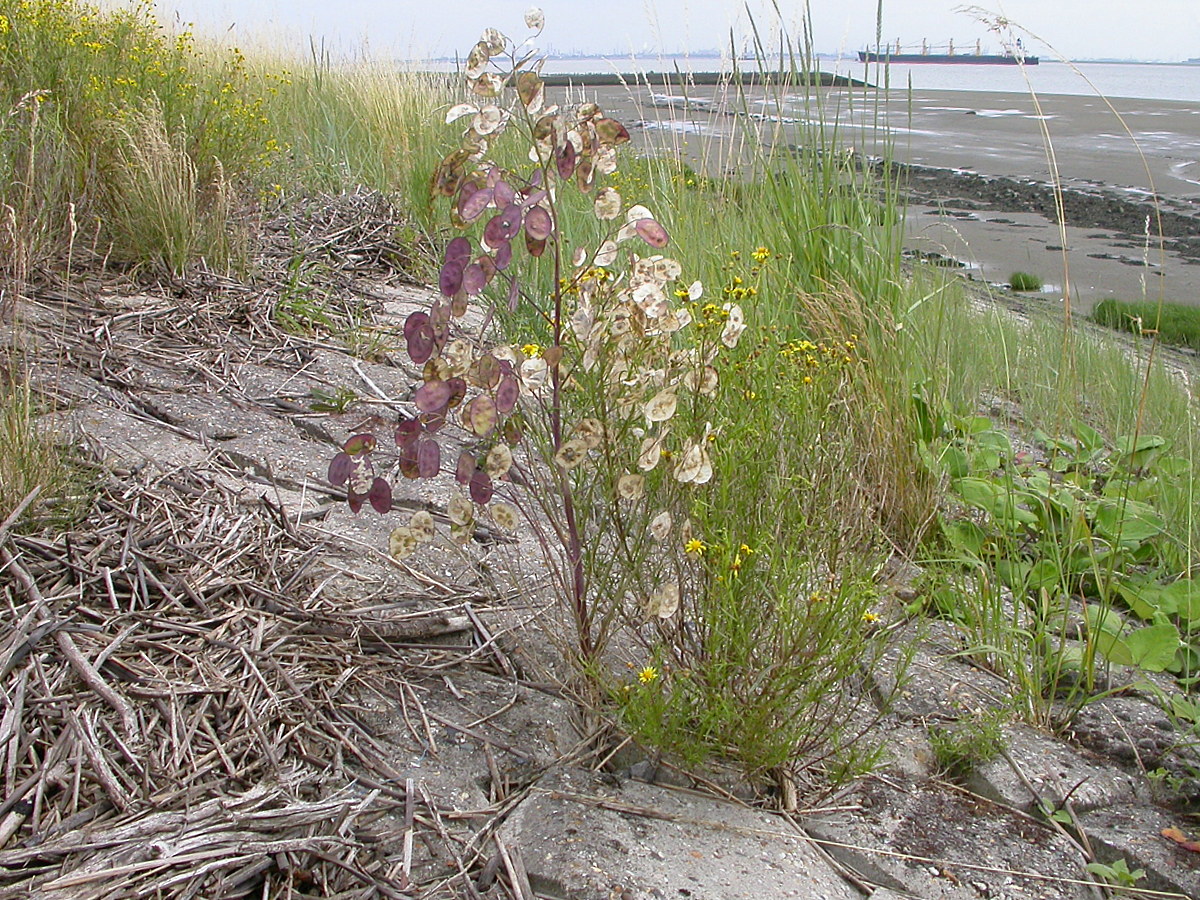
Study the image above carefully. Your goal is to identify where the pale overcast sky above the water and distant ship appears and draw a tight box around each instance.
[150,0,1200,60]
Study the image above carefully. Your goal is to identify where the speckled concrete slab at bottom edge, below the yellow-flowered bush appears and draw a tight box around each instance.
[500,769,862,900]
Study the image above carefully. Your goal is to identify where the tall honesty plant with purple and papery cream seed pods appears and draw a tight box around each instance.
[329,10,745,659]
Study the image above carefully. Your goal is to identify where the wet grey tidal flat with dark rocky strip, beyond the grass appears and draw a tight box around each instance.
[576,86,1200,310]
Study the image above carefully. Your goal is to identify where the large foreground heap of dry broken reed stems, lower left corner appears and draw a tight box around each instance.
[0,472,511,898]
